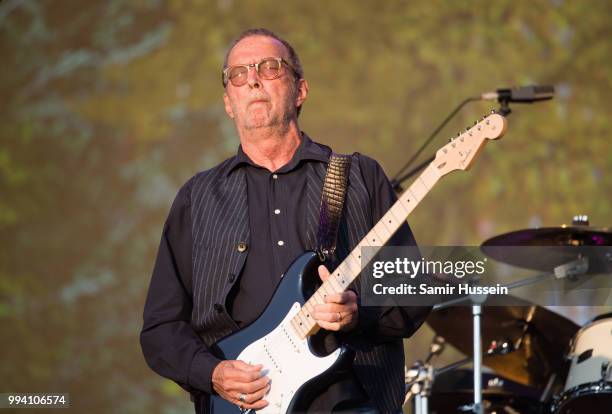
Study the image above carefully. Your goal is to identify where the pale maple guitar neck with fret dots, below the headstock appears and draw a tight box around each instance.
[291,163,441,338]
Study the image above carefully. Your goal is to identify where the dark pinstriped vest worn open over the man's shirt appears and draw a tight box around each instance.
[191,156,404,413]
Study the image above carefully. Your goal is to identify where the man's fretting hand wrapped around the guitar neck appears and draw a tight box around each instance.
[312,265,359,332]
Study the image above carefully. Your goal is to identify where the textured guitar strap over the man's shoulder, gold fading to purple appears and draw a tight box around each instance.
[317,153,351,262]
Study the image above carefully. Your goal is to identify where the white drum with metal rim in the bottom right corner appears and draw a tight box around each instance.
[552,313,612,414]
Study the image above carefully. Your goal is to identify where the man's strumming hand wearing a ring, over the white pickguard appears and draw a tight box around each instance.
[212,360,270,410]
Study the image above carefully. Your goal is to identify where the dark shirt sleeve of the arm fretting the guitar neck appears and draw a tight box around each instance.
[357,154,431,341]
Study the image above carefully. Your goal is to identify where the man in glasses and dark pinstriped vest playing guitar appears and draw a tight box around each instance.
[141,29,427,413]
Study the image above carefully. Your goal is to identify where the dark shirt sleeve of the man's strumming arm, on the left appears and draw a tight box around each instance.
[140,178,220,394]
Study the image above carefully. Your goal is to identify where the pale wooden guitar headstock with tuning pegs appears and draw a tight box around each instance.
[433,111,508,176]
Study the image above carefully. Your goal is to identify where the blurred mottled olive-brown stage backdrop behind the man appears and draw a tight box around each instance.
[0,0,612,414]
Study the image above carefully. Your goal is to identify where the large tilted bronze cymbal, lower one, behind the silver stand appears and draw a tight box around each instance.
[427,298,579,389]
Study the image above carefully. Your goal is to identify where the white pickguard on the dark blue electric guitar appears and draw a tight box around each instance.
[237,302,341,414]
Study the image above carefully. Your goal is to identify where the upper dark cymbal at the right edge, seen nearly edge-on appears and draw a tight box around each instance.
[480,226,612,274]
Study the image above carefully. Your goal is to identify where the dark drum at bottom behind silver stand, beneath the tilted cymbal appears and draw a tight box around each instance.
[428,369,544,414]
